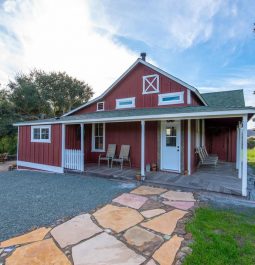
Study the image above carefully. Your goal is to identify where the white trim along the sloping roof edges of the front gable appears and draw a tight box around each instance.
[62,58,207,117]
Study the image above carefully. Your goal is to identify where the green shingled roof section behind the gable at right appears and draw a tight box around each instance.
[202,89,245,108]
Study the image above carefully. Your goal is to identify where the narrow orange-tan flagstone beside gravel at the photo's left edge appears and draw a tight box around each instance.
[0,227,50,248]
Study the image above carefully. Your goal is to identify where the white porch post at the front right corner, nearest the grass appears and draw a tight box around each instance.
[242,114,248,196]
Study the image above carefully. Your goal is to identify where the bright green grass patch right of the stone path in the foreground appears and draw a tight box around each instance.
[184,207,255,265]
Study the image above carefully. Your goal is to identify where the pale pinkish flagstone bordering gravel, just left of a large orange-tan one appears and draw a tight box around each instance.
[51,214,102,248]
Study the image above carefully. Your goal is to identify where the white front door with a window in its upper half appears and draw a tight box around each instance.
[161,121,181,172]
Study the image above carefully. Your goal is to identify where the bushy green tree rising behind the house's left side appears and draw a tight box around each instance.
[8,70,94,119]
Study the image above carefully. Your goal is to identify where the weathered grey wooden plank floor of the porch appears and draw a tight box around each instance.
[85,162,242,196]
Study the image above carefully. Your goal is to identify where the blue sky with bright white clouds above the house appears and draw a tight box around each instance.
[0,0,255,110]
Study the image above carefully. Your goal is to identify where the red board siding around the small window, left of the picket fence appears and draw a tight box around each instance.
[18,124,61,166]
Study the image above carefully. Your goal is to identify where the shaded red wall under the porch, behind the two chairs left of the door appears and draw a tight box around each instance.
[66,122,158,168]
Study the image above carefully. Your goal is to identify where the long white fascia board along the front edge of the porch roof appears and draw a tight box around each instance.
[14,109,255,126]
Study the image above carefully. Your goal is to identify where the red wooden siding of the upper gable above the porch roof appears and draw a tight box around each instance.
[72,64,202,115]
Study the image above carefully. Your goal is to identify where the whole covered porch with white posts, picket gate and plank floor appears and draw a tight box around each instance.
[62,111,248,196]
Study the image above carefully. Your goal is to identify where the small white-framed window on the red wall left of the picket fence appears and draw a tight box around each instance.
[31,125,51,143]
